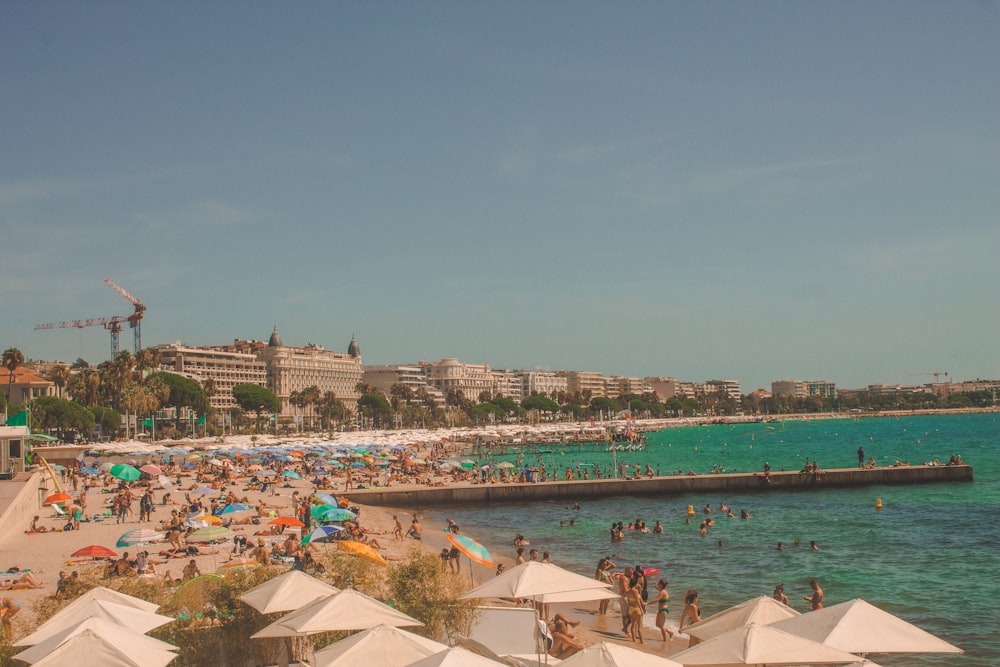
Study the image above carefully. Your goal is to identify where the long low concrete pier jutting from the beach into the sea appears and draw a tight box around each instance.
[346,465,972,507]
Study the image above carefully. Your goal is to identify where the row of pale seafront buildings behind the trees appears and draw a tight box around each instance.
[7,327,998,417]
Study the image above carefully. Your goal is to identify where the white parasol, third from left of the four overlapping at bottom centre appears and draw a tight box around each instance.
[313,625,448,667]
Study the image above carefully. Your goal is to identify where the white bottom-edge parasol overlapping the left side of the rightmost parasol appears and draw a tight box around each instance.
[670,623,858,667]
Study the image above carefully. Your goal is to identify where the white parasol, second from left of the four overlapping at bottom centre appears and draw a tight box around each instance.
[250,588,423,639]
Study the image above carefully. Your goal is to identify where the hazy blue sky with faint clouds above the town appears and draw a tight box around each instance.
[0,0,1000,392]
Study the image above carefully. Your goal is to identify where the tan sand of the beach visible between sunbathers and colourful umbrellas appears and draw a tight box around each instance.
[0,428,687,654]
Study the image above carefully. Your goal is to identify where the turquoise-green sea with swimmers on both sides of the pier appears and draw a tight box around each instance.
[427,413,1000,667]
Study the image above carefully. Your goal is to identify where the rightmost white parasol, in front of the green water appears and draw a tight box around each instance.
[772,599,963,654]
